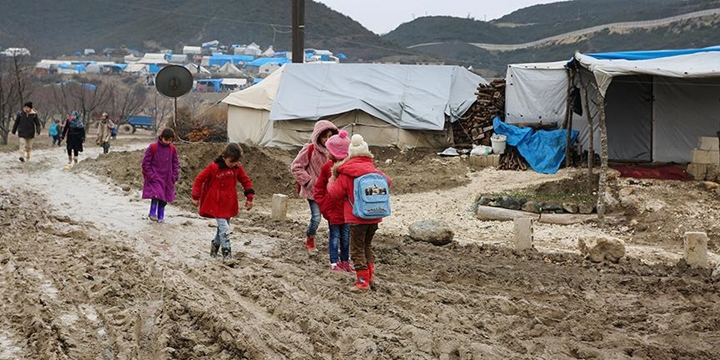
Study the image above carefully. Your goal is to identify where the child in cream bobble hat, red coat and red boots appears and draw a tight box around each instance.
[328,134,391,291]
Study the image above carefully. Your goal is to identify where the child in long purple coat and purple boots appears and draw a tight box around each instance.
[142,128,179,223]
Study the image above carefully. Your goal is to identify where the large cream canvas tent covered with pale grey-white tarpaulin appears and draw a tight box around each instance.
[223,64,487,148]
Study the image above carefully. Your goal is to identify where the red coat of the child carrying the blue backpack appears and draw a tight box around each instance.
[328,156,392,224]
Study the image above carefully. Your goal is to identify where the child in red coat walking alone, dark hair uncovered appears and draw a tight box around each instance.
[192,143,255,260]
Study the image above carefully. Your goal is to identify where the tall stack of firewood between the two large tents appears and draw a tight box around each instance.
[453,79,505,147]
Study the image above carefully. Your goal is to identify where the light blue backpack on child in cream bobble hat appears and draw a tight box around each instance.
[350,173,390,220]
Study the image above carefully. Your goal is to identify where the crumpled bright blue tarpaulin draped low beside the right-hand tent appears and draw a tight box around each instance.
[493,116,578,174]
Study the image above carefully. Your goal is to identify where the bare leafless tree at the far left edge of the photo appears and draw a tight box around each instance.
[0,55,33,145]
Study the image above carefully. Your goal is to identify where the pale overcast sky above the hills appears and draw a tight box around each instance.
[316,0,559,34]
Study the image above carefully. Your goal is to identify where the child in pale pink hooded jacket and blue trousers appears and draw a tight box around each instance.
[290,120,338,251]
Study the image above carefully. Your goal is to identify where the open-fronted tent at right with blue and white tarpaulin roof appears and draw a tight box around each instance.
[573,46,720,162]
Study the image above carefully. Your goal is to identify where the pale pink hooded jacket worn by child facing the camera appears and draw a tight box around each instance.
[290,120,338,200]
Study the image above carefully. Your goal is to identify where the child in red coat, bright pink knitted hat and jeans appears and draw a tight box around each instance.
[315,130,353,272]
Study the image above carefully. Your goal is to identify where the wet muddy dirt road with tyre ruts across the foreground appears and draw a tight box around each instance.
[0,144,720,359]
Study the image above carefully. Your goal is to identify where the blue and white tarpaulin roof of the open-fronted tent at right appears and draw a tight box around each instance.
[574,46,720,95]
